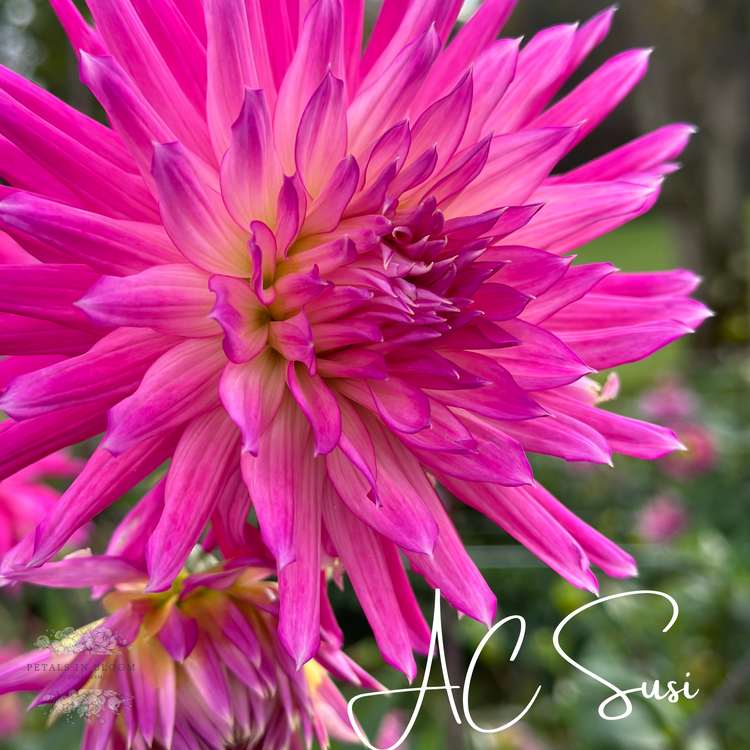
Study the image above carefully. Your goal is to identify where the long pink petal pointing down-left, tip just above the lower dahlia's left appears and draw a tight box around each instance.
[145,409,239,591]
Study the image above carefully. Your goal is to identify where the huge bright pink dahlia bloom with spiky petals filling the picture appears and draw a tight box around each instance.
[0,0,707,675]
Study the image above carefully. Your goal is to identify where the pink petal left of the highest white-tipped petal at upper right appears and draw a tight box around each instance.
[487,25,576,134]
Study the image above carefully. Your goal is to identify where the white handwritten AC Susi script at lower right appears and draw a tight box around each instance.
[349,589,699,750]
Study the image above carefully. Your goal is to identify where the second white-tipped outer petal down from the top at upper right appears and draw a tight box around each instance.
[529,50,651,148]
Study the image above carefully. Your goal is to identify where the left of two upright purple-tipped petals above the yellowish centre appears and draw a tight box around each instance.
[221,89,283,230]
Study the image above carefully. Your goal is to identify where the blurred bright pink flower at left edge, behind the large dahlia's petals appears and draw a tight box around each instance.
[0,451,86,568]
